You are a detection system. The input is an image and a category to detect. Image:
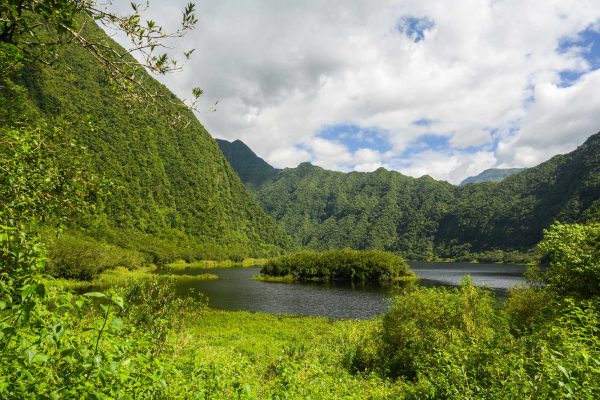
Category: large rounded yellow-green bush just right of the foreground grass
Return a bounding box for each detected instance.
[353,280,506,379]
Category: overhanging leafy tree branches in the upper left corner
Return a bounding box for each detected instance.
[0,0,202,108]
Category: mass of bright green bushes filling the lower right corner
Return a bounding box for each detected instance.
[346,284,600,399]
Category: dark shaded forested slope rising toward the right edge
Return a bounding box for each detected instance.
[438,133,600,251]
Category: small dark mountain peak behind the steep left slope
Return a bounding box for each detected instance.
[216,139,278,188]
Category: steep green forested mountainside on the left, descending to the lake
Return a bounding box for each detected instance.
[0,24,292,259]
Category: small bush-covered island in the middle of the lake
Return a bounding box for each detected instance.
[257,249,415,285]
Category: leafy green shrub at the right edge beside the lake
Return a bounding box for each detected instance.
[538,223,600,297]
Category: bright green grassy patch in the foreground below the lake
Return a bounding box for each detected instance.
[164,309,399,399]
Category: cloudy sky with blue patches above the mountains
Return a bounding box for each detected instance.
[104,0,600,183]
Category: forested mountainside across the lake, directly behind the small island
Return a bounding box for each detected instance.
[256,163,456,258]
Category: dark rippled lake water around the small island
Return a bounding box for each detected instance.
[163,263,525,319]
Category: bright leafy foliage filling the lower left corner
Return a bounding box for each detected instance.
[0,227,203,399]
